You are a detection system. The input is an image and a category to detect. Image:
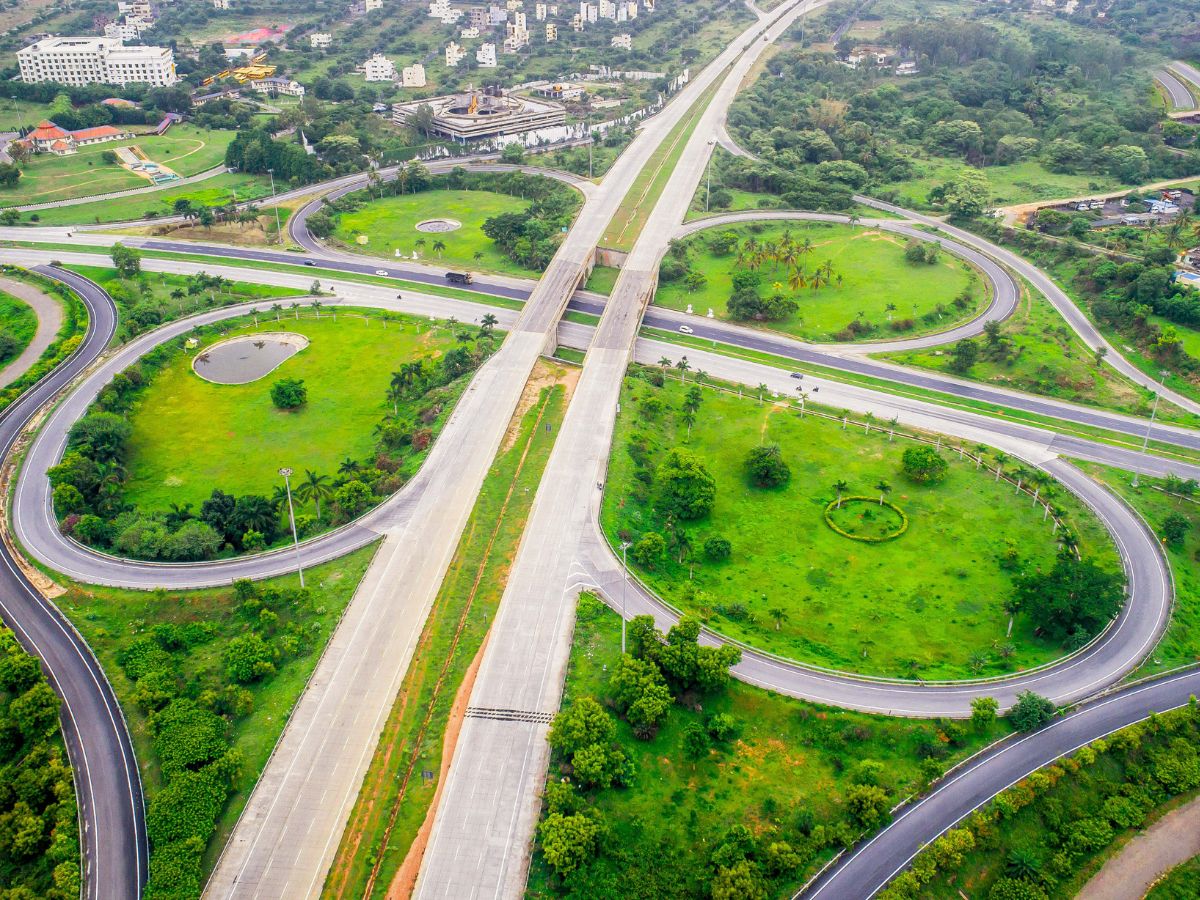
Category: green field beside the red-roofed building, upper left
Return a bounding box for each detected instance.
[0,125,234,206]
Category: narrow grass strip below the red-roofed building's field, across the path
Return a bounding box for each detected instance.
[22,172,271,226]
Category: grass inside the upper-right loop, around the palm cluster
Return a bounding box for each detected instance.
[654,222,988,341]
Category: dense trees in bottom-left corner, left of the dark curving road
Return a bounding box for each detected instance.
[0,628,82,900]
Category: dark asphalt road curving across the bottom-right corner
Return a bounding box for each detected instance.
[797,671,1200,900]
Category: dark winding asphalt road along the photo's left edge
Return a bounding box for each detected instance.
[0,266,148,900]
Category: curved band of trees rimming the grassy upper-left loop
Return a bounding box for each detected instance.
[308,163,580,270]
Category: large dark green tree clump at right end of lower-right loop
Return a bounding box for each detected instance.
[1014,556,1124,641]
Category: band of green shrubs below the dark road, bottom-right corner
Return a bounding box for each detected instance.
[880,697,1200,900]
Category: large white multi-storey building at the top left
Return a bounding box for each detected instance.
[17,37,179,86]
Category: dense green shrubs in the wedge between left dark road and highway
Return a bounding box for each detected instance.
[116,581,324,900]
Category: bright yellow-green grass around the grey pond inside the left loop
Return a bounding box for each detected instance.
[125,310,455,511]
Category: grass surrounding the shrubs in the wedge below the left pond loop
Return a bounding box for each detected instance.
[55,545,374,883]
